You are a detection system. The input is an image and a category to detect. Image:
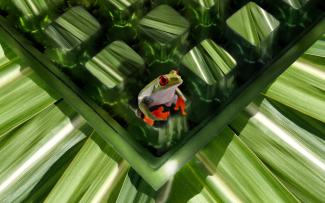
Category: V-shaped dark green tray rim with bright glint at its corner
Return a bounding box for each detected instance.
[0,16,325,189]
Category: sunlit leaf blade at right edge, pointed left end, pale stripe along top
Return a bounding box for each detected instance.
[265,60,325,122]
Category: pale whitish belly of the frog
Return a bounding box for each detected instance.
[149,87,177,107]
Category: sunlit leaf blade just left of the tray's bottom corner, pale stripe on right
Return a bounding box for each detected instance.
[45,135,129,202]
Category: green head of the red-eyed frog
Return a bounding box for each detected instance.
[155,70,183,91]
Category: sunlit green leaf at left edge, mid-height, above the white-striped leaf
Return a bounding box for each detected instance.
[0,50,55,137]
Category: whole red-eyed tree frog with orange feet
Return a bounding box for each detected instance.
[138,70,186,126]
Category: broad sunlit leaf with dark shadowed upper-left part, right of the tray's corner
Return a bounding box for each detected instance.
[166,128,297,202]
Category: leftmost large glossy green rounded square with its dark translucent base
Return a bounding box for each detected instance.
[44,7,100,67]
